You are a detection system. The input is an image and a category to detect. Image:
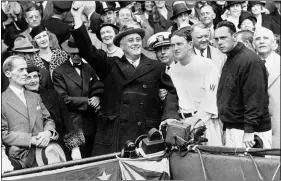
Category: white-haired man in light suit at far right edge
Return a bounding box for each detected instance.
[254,27,280,148]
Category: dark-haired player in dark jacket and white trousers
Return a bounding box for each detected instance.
[215,21,272,148]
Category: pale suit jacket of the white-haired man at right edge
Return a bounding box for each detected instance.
[266,52,280,148]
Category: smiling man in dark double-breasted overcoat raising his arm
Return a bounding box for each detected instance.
[71,1,179,156]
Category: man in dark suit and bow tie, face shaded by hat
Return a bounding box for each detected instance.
[53,37,103,160]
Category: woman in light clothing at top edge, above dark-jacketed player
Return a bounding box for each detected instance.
[221,1,244,30]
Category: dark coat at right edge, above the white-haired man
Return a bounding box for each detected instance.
[262,10,281,35]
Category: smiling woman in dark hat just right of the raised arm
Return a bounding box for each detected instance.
[97,23,124,58]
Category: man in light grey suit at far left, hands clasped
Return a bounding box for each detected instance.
[1,55,61,169]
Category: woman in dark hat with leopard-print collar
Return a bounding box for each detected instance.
[30,25,67,79]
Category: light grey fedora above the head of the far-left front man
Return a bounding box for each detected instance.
[12,37,39,53]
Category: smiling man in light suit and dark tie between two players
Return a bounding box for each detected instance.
[191,23,226,72]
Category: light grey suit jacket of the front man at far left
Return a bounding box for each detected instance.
[1,88,56,159]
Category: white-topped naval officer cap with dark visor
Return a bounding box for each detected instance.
[147,32,171,50]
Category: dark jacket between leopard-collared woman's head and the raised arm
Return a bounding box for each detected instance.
[43,17,70,45]
